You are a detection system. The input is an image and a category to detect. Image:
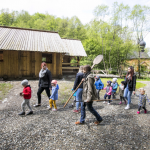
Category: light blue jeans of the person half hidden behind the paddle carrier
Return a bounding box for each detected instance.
[76,88,83,110]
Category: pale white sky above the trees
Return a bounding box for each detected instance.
[0,0,150,47]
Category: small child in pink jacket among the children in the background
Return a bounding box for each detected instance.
[103,81,112,105]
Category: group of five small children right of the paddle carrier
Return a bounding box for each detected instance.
[95,76,150,114]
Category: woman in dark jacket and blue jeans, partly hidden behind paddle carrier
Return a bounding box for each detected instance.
[73,66,84,113]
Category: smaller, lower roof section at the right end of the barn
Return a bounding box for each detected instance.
[62,39,87,56]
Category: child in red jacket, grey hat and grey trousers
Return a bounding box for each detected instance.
[18,79,33,115]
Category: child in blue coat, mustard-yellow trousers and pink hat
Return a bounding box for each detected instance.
[48,80,59,111]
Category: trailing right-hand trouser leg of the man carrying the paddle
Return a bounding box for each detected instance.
[86,102,103,121]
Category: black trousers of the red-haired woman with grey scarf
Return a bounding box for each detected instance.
[37,87,51,104]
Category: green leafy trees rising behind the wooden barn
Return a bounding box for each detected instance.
[0,2,150,73]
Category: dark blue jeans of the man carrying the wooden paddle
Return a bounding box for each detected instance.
[80,102,103,123]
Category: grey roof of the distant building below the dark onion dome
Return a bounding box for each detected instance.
[128,51,150,59]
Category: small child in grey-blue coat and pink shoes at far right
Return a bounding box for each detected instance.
[136,88,150,114]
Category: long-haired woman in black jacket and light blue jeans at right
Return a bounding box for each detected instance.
[124,66,136,109]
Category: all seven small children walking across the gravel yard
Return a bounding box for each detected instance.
[19,76,149,115]
